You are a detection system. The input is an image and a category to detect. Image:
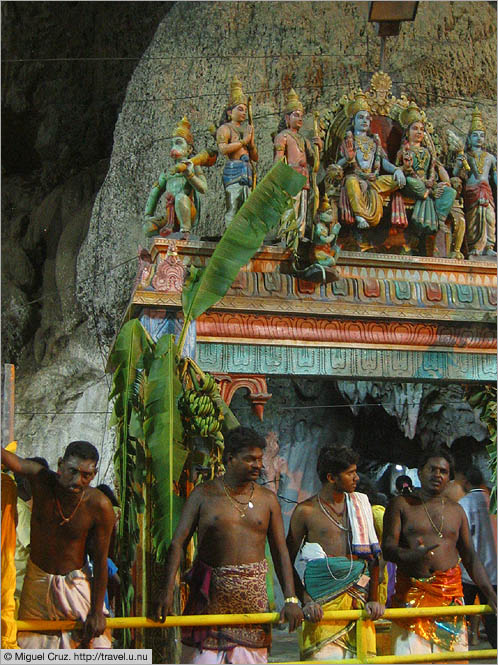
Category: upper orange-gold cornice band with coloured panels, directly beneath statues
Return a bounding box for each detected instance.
[132,238,496,324]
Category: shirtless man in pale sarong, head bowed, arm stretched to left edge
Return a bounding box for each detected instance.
[2,441,114,649]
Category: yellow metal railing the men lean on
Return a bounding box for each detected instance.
[17,605,497,665]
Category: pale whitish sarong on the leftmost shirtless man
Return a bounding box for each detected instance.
[18,559,111,649]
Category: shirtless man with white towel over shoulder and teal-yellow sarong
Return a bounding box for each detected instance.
[287,446,384,662]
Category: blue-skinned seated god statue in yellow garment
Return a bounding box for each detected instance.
[337,91,405,229]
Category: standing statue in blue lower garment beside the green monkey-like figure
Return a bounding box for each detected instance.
[216,78,258,228]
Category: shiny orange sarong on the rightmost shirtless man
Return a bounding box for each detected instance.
[392,566,467,651]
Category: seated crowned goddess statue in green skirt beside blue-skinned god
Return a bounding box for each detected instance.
[396,102,456,235]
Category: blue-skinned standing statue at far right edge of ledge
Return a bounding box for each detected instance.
[453,107,496,256]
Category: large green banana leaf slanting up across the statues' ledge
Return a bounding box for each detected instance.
[179,161,306,330]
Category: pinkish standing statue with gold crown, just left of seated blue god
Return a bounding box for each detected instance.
[273,88,323,237]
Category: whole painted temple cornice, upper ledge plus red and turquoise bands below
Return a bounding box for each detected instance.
[127,238,496,384]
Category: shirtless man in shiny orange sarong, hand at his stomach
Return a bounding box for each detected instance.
[382,447,496,655]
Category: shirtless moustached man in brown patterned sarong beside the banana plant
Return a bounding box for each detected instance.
[153,427,303,663]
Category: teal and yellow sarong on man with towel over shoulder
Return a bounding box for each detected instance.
[299,557,375,660]
